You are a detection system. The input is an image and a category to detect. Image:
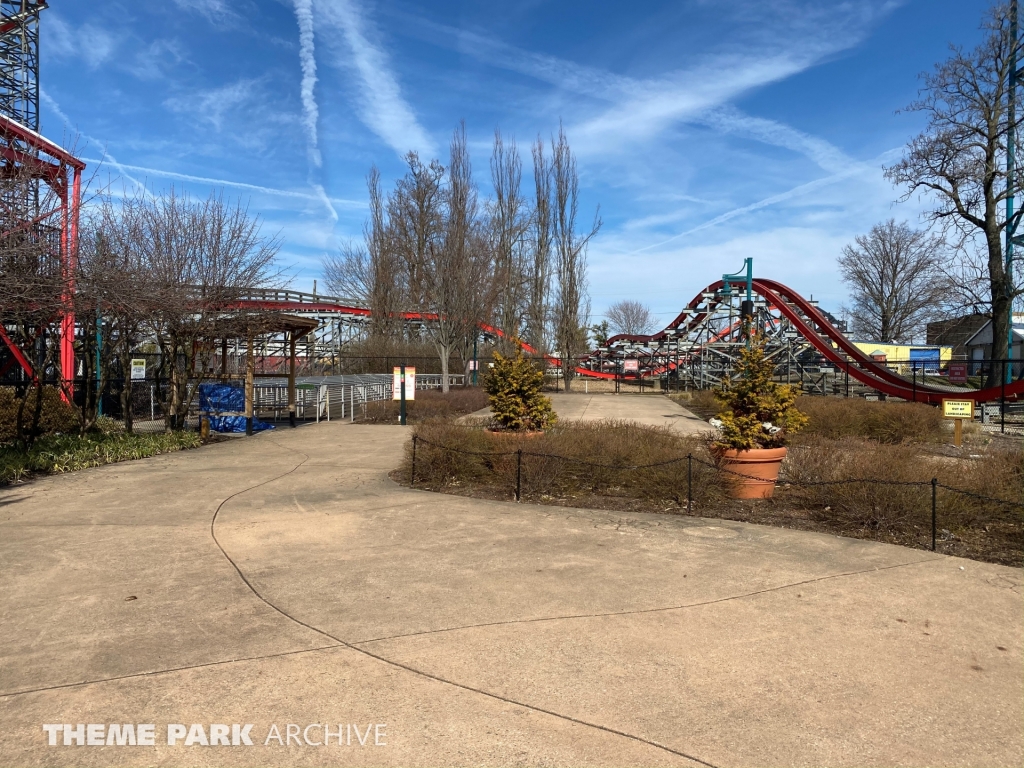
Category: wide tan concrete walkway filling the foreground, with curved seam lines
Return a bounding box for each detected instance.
[0,423,1024,766]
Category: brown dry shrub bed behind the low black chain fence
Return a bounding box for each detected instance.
[392,421,1024,565]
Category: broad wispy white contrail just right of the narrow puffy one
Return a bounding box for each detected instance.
[316,0,436,157]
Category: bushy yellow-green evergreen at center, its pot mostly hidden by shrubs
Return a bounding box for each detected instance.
[484,339,556,432]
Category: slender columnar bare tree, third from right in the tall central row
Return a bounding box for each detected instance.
[489,130,530,352]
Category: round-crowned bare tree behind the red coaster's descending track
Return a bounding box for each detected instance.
[839,219,948,343]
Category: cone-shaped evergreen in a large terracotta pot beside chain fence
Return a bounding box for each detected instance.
[712,334,807,499]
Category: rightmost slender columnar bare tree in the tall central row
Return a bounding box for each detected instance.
[551,126,601,391]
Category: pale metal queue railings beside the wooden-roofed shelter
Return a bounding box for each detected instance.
[255,374,466,422]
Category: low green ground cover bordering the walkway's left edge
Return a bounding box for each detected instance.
[0,432,200,484]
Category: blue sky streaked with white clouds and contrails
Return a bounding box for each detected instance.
[41,0,987,322]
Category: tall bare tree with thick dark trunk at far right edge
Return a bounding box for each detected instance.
[886,4,1022,370]
